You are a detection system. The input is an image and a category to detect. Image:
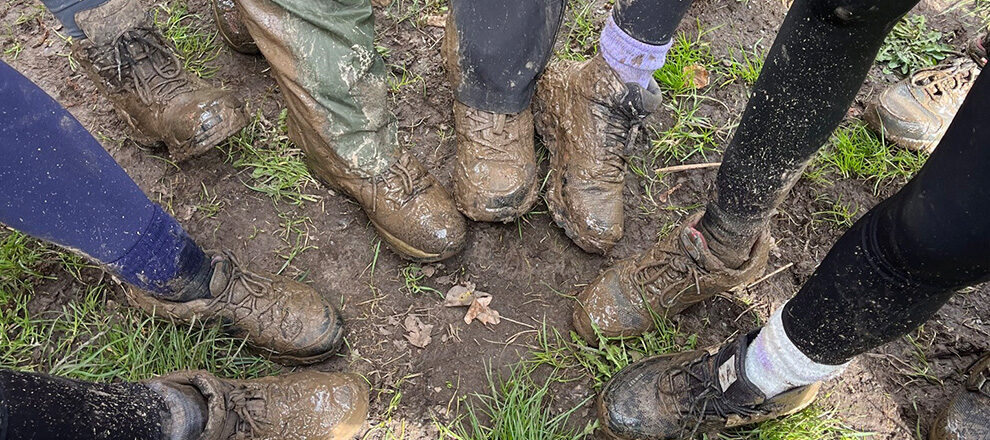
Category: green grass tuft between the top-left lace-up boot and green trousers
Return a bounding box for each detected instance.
[153,0,223,78]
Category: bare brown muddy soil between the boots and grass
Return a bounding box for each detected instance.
[0,0,990,439]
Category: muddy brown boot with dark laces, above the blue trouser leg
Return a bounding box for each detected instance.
[72,0,248,162]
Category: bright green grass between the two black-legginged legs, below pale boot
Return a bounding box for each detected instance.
[805,122,928,191]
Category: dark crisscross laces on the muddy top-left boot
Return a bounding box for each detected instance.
[88,28,192,105]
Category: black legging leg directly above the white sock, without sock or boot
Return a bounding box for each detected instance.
[782,71,990,365]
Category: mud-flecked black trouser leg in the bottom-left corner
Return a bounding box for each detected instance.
[0,369,168,440]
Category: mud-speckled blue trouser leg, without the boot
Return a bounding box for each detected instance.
[0,62,210,300]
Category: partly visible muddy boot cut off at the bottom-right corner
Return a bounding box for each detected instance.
[928,353,990,440]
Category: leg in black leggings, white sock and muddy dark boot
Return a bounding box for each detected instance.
[601,49,990,438]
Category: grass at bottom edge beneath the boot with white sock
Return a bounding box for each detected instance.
[717,405,873,440]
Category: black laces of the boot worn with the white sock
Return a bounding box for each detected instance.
[659,353,768,438]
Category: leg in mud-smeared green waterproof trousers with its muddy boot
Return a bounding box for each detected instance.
[237,0,466,261]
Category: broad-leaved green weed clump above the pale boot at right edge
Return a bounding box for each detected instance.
[877,14,952,75]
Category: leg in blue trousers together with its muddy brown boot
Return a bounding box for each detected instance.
[0,63,343,364]
